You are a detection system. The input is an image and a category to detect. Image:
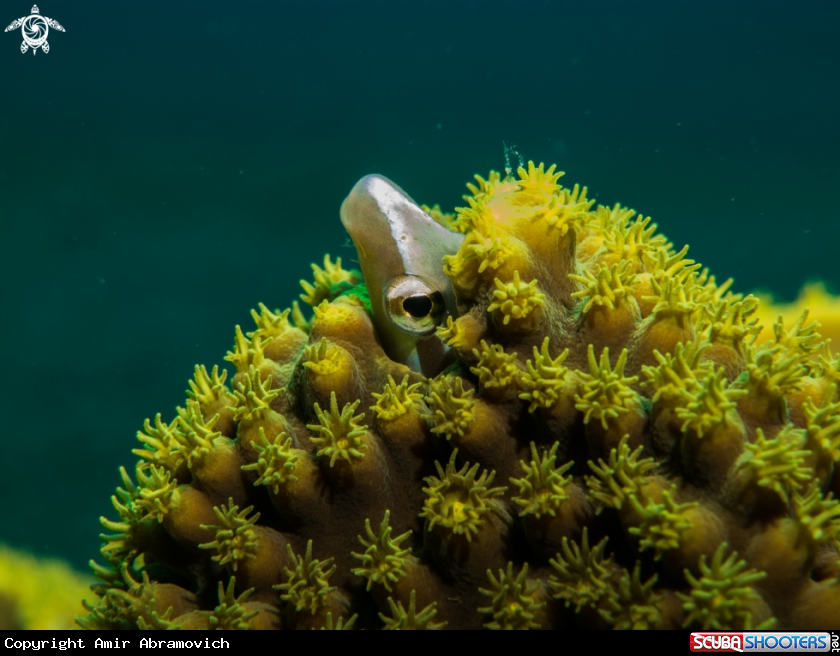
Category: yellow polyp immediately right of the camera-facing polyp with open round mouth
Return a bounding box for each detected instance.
[510,442,574,517]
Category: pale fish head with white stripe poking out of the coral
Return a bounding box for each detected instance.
[340,174,464,377]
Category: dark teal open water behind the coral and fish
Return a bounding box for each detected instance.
[0,0,840,567]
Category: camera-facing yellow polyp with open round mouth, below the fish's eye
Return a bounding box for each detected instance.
[420,449,507,541]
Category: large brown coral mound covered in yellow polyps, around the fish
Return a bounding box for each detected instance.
[79,163,840,630]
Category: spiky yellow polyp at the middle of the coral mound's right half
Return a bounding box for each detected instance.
[575,344,639,430]
